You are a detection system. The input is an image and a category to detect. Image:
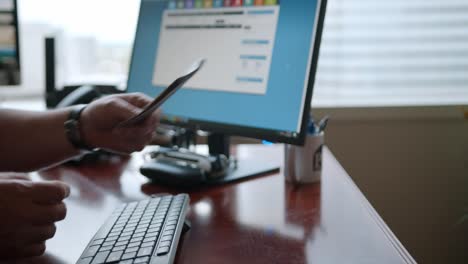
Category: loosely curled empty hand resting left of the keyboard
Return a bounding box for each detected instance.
[0,174,70,260]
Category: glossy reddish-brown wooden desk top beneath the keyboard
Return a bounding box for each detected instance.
[23,146,414,264]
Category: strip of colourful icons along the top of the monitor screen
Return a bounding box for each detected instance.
[169,0,280,9]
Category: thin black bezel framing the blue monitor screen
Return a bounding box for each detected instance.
[127,0,327,145]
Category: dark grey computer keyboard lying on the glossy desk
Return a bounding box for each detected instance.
[76,194,189,264]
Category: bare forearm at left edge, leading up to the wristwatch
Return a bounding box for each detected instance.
[0,109,79,172]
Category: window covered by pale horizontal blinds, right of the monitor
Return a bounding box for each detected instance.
[313,0,468,107]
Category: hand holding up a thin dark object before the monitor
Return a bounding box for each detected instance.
[80,93,160,153]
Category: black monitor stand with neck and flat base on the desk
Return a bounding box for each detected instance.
[202,133,280,185]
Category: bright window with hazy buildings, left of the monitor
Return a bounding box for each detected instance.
[0,0,140,97]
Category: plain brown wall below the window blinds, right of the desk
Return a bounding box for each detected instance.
[313,107,468,263]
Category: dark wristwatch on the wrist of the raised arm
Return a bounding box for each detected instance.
[64,105,95,152]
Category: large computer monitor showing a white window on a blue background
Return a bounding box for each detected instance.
[128,0,325,144]
